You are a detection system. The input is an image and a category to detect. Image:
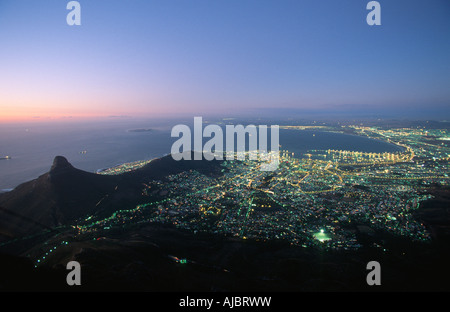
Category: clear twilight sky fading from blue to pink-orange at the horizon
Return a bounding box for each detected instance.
[0,0,450,122]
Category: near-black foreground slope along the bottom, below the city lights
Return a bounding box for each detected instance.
[0,225,450,292]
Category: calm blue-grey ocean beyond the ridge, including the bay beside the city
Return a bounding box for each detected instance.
[0,117,401,190]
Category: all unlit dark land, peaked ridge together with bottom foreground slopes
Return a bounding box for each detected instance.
[0,157,450,292]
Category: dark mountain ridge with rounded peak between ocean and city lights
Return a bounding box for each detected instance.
[0,155,220,242]
